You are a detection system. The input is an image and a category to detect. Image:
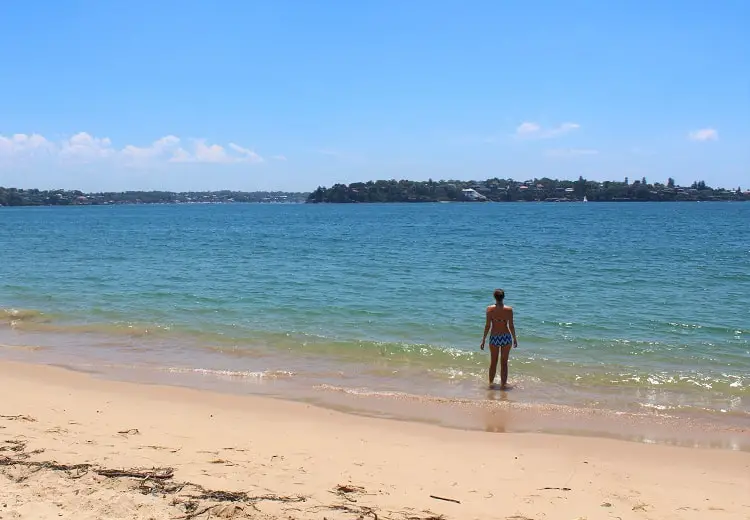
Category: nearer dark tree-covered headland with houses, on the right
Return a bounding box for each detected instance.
[307,177,750,203]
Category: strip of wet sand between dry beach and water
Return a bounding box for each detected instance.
[0,330,750,452]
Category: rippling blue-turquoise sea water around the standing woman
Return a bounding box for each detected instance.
[0,203,750,425]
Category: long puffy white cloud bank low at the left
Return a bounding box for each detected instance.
[0,132,270,166]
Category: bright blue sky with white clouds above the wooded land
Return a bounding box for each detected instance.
[0,0,750,190]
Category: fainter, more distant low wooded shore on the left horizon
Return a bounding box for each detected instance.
[0,187,308,206]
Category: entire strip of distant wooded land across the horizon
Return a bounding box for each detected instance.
[0,177,750,206]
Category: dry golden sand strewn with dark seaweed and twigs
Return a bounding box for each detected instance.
[0,362,750,520]
